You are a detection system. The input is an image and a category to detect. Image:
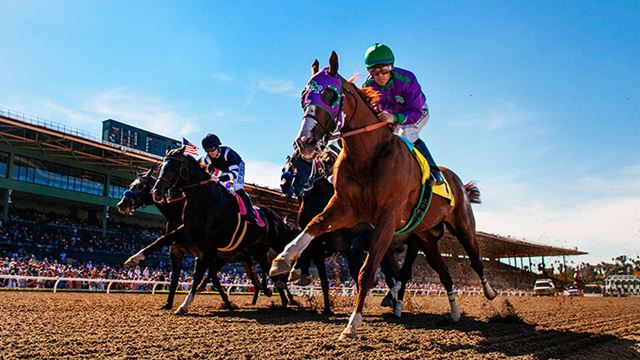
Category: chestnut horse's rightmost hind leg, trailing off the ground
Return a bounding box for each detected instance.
[447,215,497,300]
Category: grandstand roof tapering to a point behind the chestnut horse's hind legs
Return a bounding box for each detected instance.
[440,231,587,259]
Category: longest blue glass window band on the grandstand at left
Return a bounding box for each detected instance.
[13,155,105,196]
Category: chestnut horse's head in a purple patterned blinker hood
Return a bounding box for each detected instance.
[295,52,343,161]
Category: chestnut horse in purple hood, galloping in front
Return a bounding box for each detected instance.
[270,52,496,339]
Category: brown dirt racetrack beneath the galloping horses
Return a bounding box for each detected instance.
[0,292,640,360]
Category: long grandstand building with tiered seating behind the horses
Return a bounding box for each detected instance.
[0,108,585,288]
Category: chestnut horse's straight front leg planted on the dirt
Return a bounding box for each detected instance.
[340,213,395,340]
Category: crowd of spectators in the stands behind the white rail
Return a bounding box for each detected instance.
[0,212,535,293]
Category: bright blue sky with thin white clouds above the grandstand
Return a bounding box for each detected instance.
[0,0,640,262]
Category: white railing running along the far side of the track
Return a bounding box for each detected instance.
[0,275,533,296]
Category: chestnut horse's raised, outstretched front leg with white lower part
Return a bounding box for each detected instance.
[269,196,356,277]
